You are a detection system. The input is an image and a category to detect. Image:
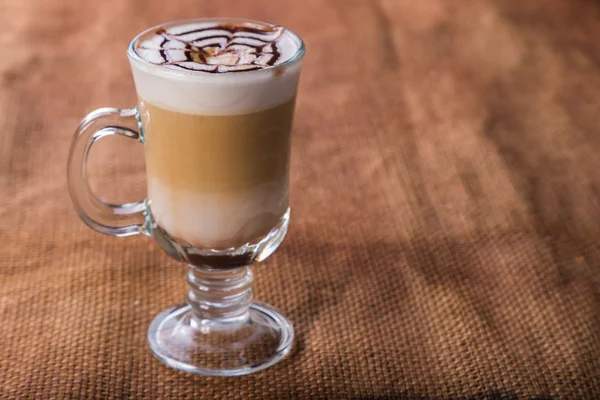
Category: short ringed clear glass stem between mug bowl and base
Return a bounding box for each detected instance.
[187,265,253,329]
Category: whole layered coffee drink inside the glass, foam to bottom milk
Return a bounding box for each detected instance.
[131,21,300,249]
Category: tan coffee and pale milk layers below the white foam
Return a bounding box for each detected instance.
[139,98,294,248]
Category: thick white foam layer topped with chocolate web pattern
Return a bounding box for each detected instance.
[128,19,304,115]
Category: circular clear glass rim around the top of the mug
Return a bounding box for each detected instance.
[127,17,306,79]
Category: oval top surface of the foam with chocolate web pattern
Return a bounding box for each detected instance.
[136,23,284,73]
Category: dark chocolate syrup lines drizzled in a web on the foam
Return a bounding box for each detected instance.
[139,24,284,73]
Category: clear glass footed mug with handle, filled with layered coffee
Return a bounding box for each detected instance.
[68,19,305,376]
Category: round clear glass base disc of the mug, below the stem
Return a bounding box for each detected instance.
[148,303,294,376]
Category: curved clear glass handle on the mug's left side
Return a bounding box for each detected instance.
[67,107,146,236]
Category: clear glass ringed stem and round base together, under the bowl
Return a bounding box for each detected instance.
[148,267,294,376]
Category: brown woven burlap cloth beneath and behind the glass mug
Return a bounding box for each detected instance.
[0,0,600,399]
